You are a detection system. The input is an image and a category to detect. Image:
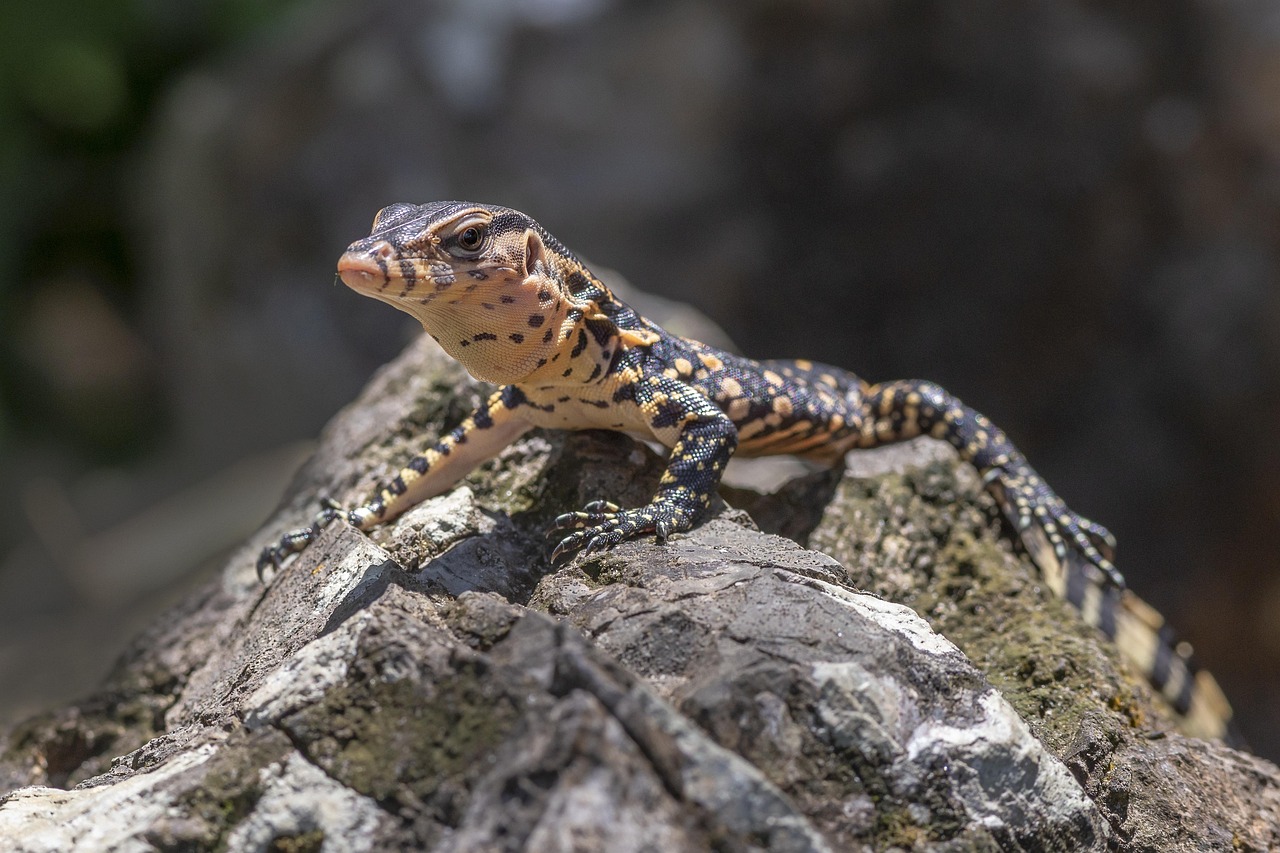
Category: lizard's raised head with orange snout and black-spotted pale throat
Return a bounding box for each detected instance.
[338,201,584,384]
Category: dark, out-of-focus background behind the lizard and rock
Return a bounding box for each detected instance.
[0,0,1280,758]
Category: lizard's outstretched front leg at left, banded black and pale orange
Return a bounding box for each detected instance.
[257,386,532,579]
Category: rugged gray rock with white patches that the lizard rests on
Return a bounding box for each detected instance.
[0,338,1280,850]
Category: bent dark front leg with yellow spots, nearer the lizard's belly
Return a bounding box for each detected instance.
[550,380,737,562]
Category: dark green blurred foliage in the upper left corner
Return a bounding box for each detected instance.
[0,0,307,461]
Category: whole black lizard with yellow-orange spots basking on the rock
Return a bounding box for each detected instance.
[259,201,1228,737]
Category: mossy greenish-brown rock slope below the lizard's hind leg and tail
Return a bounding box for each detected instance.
[809,450,1171,754]
